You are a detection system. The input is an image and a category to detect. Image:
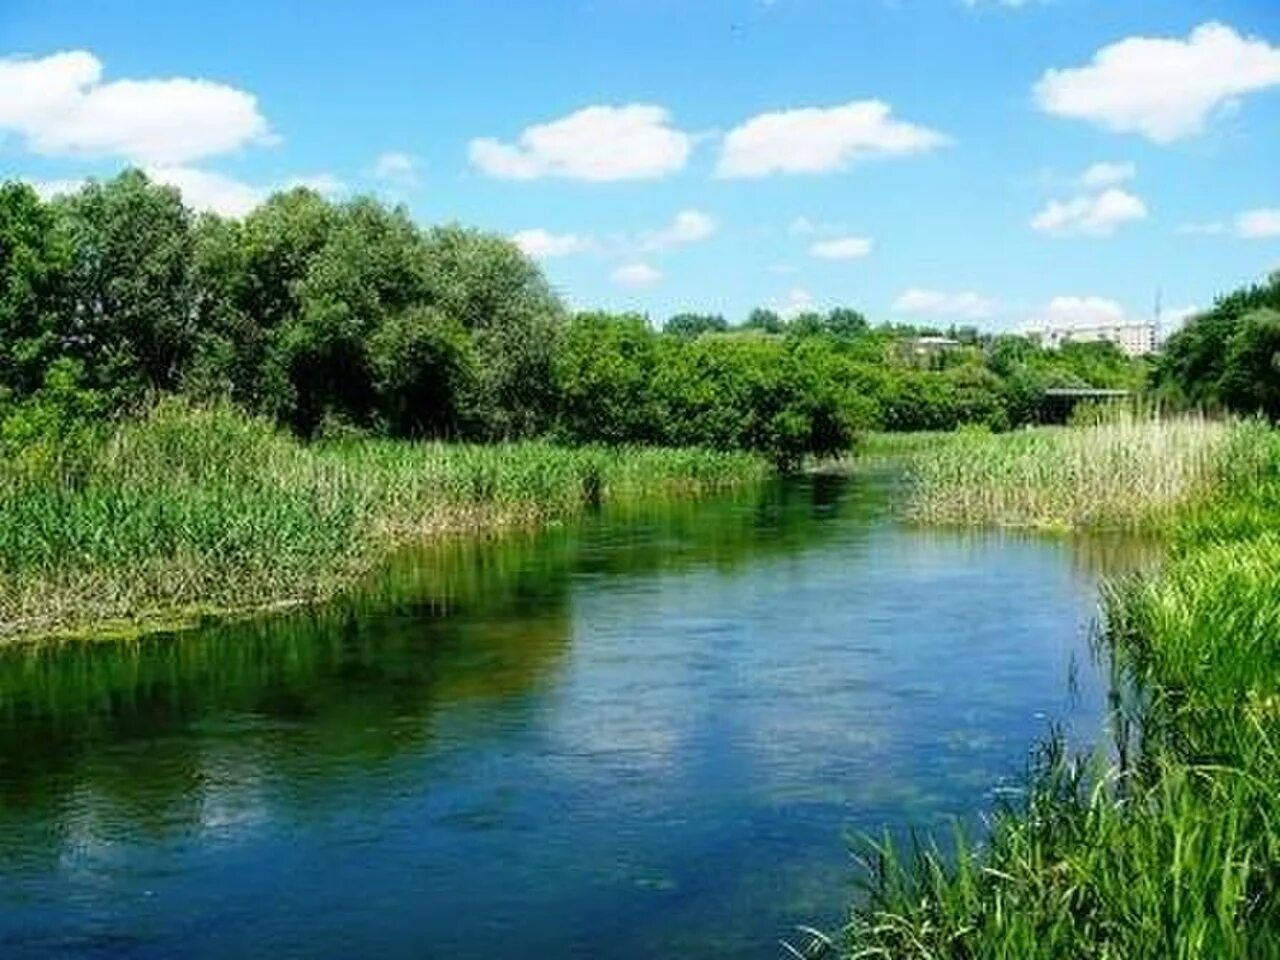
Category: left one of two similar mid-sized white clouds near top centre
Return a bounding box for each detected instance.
[468,104,692,182]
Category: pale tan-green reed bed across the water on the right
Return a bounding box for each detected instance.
[908,417,1262,530]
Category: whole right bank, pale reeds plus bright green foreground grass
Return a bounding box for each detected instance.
[838,421,1280,960]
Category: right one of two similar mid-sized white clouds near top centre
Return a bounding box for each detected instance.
[716,100,947,178]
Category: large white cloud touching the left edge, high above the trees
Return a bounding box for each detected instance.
[0,50,271,166]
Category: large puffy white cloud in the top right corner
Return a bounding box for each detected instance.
[1034,23,1280,143]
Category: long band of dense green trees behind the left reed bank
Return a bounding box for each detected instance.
[0,170,1152,465]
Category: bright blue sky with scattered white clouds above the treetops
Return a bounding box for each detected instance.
[0,0,1280,329]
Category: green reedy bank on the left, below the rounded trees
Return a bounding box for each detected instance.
[0,402,765,639]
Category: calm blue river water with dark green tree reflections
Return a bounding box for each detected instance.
[0,477,1114,960]
